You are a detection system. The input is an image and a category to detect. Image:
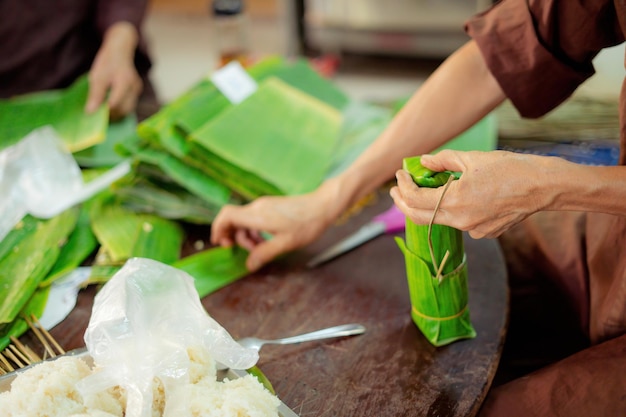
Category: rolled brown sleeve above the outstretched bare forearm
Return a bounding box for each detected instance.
[465,0,624,117]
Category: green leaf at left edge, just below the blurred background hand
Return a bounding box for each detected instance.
[0,76,109,152]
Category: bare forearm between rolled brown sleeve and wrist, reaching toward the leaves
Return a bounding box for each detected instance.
[321,42,505,211]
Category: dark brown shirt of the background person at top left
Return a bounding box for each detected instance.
[0,0,150,98]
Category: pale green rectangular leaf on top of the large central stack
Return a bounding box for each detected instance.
[191,77,341,195]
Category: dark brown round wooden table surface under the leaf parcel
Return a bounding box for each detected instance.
[51,194,508,417]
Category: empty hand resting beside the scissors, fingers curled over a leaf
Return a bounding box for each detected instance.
[211,190,339,272]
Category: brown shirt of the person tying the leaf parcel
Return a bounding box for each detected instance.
[466,0,626,343]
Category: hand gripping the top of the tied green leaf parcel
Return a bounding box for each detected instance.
[390,150,559,238]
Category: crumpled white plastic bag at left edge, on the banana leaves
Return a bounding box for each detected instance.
[0,126,130,240]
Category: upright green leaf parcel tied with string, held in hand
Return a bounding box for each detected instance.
[396,157,476,346]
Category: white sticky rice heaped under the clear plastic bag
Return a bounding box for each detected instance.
[0,348,298,417]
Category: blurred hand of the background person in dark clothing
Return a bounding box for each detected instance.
[85,22,143,120]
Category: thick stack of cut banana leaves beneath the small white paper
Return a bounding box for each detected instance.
[118,57,349,211]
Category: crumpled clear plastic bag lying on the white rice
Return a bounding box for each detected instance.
[78,258,258,417]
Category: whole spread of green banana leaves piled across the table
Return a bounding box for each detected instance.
[0,57,392,349]
